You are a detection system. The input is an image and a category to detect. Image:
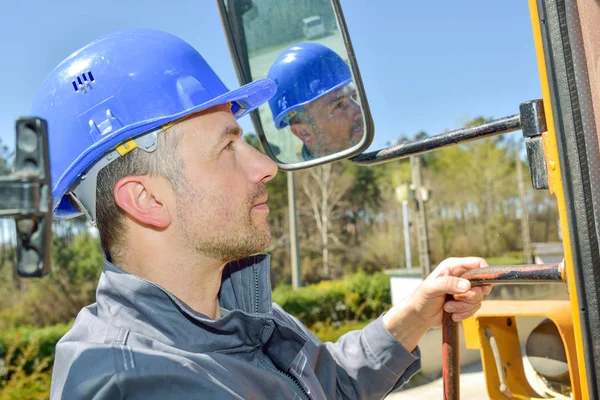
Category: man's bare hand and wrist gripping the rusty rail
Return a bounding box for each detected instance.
[383,257,492,351]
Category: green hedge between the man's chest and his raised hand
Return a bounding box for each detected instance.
[273,272,391,327]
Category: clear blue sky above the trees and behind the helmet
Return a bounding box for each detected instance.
[0,0,541,153]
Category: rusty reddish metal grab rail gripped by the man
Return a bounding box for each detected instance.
[442,260,565,400]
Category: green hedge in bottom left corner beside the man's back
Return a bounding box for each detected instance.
[0,324,71,400]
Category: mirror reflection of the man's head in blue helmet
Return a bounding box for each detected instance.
[267,43,364,160]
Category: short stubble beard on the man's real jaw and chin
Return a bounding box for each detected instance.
[177,184,271,262]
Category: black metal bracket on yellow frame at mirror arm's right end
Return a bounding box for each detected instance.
[519,100,548,189]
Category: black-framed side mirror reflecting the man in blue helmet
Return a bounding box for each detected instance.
[217,0,374,171]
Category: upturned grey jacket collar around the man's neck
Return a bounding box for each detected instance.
[96,255,273,352]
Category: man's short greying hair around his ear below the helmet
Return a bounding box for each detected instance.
[96,125,185,261]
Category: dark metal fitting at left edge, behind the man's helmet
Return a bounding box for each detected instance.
[0,118,52,277]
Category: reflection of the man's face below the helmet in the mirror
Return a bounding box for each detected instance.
[290,84,364,157]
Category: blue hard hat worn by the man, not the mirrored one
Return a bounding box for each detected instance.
[31,29,276,222]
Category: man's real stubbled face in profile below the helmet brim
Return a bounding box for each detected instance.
[175,106,277,262]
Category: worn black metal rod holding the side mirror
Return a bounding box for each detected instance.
[351,110,521,165]
